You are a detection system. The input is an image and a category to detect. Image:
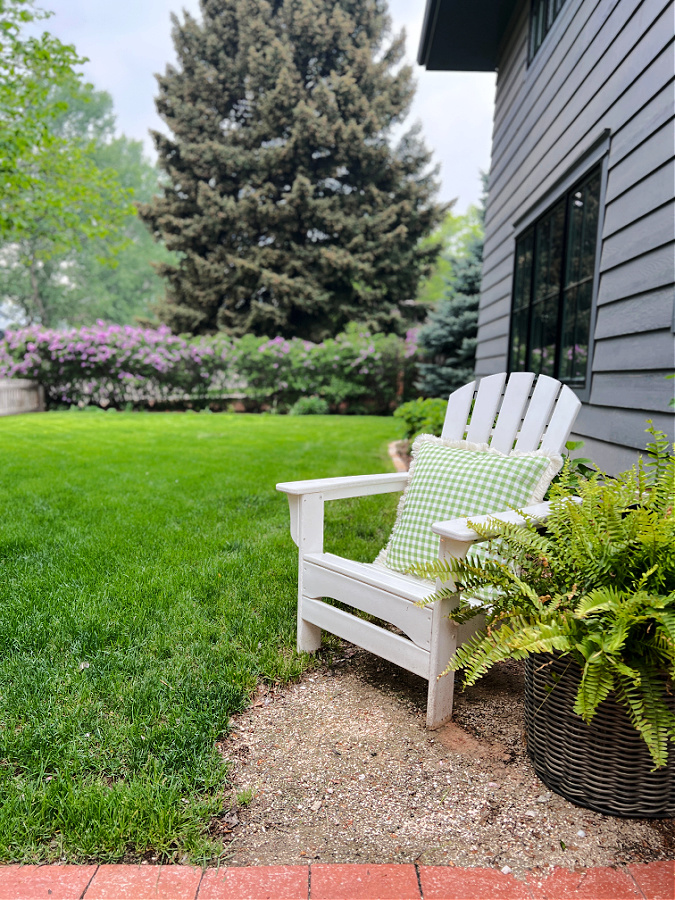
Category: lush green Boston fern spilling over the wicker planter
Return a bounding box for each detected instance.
[416,432,675,767]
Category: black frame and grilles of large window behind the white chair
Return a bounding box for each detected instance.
[508,164,607,399]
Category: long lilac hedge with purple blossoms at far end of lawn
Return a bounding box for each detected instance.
[0,322,416,413]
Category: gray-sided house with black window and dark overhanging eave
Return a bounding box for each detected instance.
[418,0,675,471]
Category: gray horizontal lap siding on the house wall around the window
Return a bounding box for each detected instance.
[476,0,675,469]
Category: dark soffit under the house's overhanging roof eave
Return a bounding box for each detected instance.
[417,0,518,72]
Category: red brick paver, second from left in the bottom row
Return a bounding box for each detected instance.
[86,866,202,900]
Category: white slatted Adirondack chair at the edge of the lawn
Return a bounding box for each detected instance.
[277,372,581,728]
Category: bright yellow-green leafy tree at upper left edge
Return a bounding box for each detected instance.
[0,0,133,298]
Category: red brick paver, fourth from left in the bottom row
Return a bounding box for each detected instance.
[310,865,420,900]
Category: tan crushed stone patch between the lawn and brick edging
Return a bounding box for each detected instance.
[217,645,675,875]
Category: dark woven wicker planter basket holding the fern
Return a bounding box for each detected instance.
[525,654,675,818]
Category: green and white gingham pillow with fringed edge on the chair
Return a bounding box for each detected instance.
[375,434,562,572]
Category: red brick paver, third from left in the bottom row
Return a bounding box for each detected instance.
[198,866,309,900]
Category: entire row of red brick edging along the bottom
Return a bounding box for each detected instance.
[0,860,675,900]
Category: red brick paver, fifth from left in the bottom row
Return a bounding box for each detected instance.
[420,866,531,900]
